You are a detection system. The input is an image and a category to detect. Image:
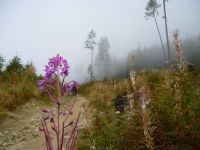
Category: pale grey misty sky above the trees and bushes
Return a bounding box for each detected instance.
[0,0,200,81]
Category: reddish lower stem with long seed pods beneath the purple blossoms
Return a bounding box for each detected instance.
[41,98,80,150]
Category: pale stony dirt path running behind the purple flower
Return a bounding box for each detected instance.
[0,97,88,150]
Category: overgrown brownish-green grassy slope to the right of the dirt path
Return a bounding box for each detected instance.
[78,70,200,150]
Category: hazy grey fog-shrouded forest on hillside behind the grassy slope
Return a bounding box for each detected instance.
[95,37,200,80]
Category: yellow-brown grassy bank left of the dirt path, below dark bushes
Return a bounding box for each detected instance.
[0,74,44,120]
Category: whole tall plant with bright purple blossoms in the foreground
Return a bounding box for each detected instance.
[38,54,80,150]
